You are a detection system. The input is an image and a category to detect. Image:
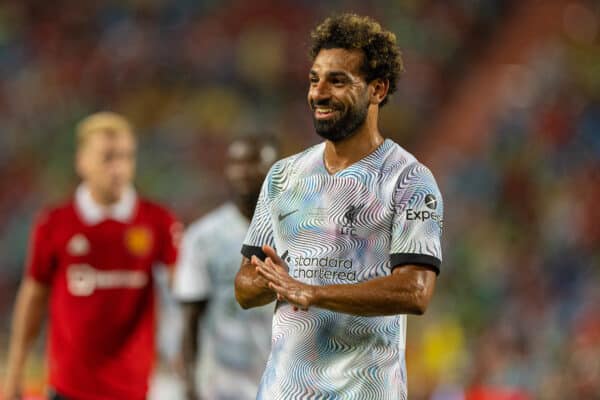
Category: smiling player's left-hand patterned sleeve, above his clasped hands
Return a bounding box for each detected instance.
[242,164,277,260]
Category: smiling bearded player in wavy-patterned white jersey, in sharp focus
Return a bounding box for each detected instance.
[236,14,443,400]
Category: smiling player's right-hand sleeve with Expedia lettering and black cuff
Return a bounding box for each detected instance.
[390,163,444,274]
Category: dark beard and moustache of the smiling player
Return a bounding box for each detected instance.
[311,96,369,142]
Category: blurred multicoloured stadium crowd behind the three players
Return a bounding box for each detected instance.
[0,0,600,400]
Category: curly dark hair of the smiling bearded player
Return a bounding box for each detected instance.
[309,13,404,107]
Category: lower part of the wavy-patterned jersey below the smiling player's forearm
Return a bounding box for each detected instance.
[259,305,401,399]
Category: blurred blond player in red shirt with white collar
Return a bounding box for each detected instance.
[4,112,180,400]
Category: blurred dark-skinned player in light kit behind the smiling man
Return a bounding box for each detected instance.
[174,135,277,400]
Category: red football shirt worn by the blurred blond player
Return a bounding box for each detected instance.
[27,188,179,400]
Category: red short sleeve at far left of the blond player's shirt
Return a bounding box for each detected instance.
[25,212,58,284]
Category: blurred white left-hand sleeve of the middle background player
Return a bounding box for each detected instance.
[173,225,211,301]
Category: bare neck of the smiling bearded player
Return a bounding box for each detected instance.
[323,116,383,174]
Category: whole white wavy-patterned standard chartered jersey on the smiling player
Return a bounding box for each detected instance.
[245,140,442,400]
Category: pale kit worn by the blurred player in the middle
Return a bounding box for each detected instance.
[174,203,273,400]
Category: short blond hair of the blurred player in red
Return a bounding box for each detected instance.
[75,111,135,148]
